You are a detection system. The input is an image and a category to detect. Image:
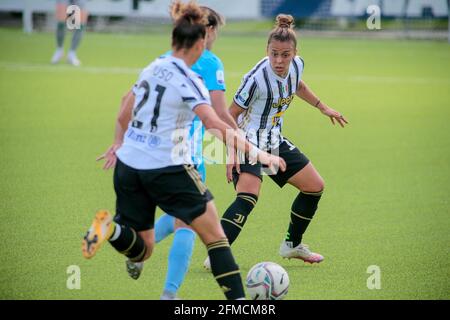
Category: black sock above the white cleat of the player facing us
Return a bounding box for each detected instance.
[286,191,323,248]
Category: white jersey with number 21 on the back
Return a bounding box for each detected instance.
[116,56,211,170]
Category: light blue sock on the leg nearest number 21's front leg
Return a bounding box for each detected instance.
[164,228,195,295]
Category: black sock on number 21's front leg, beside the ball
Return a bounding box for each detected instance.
[207,239,245,300]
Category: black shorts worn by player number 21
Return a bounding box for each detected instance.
[114,159,213,231]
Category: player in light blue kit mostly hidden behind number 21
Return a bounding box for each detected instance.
[149,6,237,300]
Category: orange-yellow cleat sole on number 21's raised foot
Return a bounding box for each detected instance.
[81,210,114,259]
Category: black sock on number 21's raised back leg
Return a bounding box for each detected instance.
[109,224,146,262]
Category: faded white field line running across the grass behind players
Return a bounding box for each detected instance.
[0,61,450,85]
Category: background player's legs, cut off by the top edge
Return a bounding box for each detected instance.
[51,0,88,67]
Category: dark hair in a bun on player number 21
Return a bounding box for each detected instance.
[170,0,208,50]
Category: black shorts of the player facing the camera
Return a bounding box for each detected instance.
[233,138,309,188]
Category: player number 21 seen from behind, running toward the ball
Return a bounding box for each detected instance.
[82,0,286,299]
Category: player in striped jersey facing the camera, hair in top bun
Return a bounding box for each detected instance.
[205,14,347,269]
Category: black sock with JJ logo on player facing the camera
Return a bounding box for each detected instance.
[220,193,258,245]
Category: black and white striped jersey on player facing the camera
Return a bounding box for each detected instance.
[234,56,304,150]
